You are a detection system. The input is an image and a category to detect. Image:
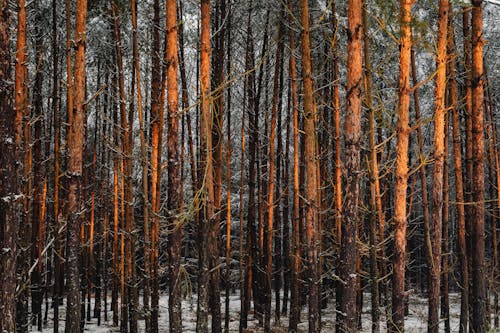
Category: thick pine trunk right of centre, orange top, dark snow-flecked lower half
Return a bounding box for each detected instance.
[340,0,363,332]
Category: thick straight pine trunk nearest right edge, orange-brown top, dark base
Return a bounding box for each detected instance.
[471,0,489,332]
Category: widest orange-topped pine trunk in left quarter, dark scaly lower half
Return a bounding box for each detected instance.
[66,0,87,333]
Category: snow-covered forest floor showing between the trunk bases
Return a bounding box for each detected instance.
[32,293,484,333]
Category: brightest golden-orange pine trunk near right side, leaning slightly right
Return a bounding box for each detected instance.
[427,0,449,333]
